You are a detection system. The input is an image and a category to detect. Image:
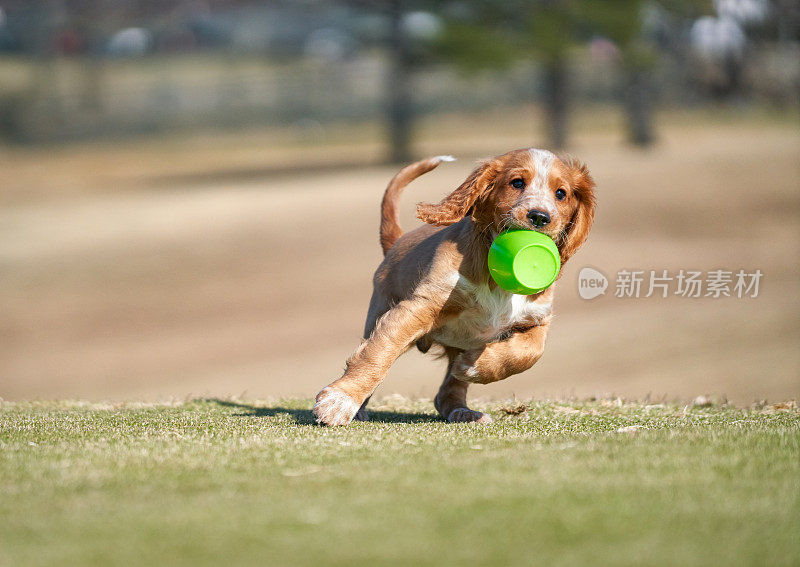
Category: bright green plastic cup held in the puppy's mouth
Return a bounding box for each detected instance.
[488,230,561,295]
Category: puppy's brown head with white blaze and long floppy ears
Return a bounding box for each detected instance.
[417,149,595,262]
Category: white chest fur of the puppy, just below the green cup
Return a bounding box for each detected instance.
[431,276,551,349]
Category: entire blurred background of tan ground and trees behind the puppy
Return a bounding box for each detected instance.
[0,0,800,404]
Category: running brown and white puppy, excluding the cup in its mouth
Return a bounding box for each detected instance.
[314,149,595,425]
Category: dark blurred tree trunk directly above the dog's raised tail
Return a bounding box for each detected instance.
[386,0,413,163]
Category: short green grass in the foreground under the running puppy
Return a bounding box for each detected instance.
[0,399,800,566]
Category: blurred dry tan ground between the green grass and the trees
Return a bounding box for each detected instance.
[0,108,800,403]
